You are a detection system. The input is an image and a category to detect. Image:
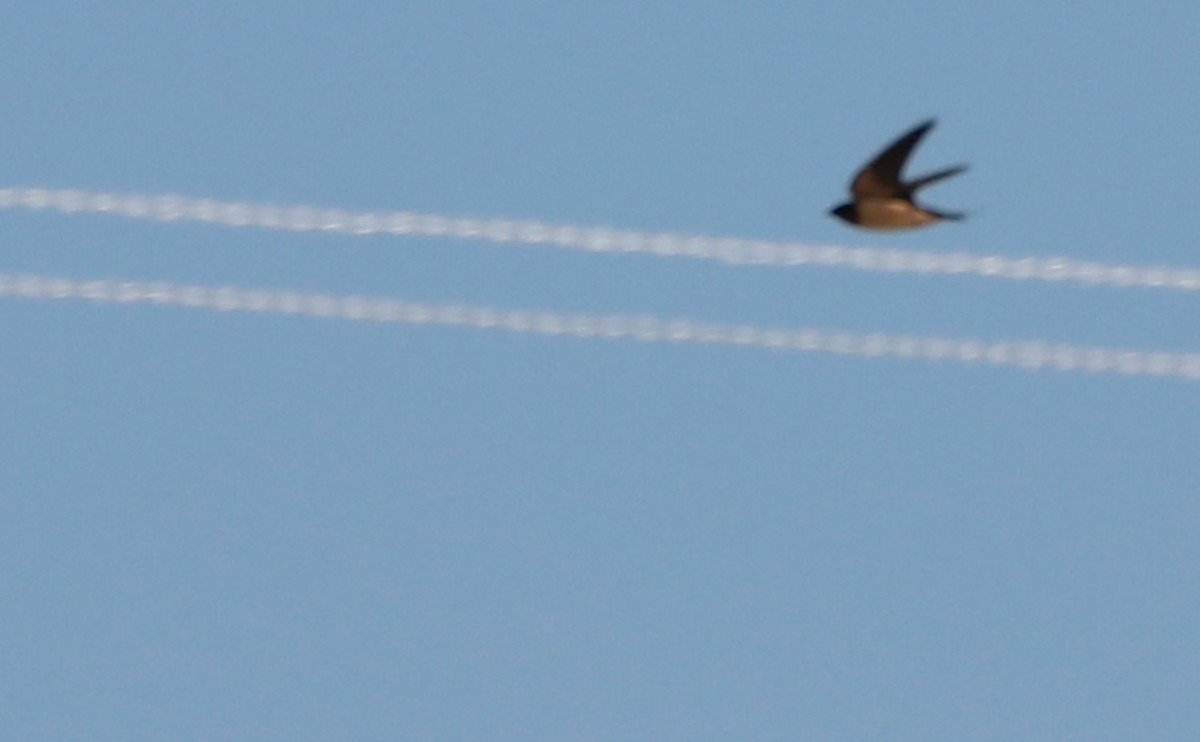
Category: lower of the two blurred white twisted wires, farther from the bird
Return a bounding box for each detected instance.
[0,274,1200,381]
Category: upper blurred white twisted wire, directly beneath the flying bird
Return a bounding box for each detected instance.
[0,183,1200,291]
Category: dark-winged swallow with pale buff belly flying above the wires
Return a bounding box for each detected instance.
[829,119,967,232]
